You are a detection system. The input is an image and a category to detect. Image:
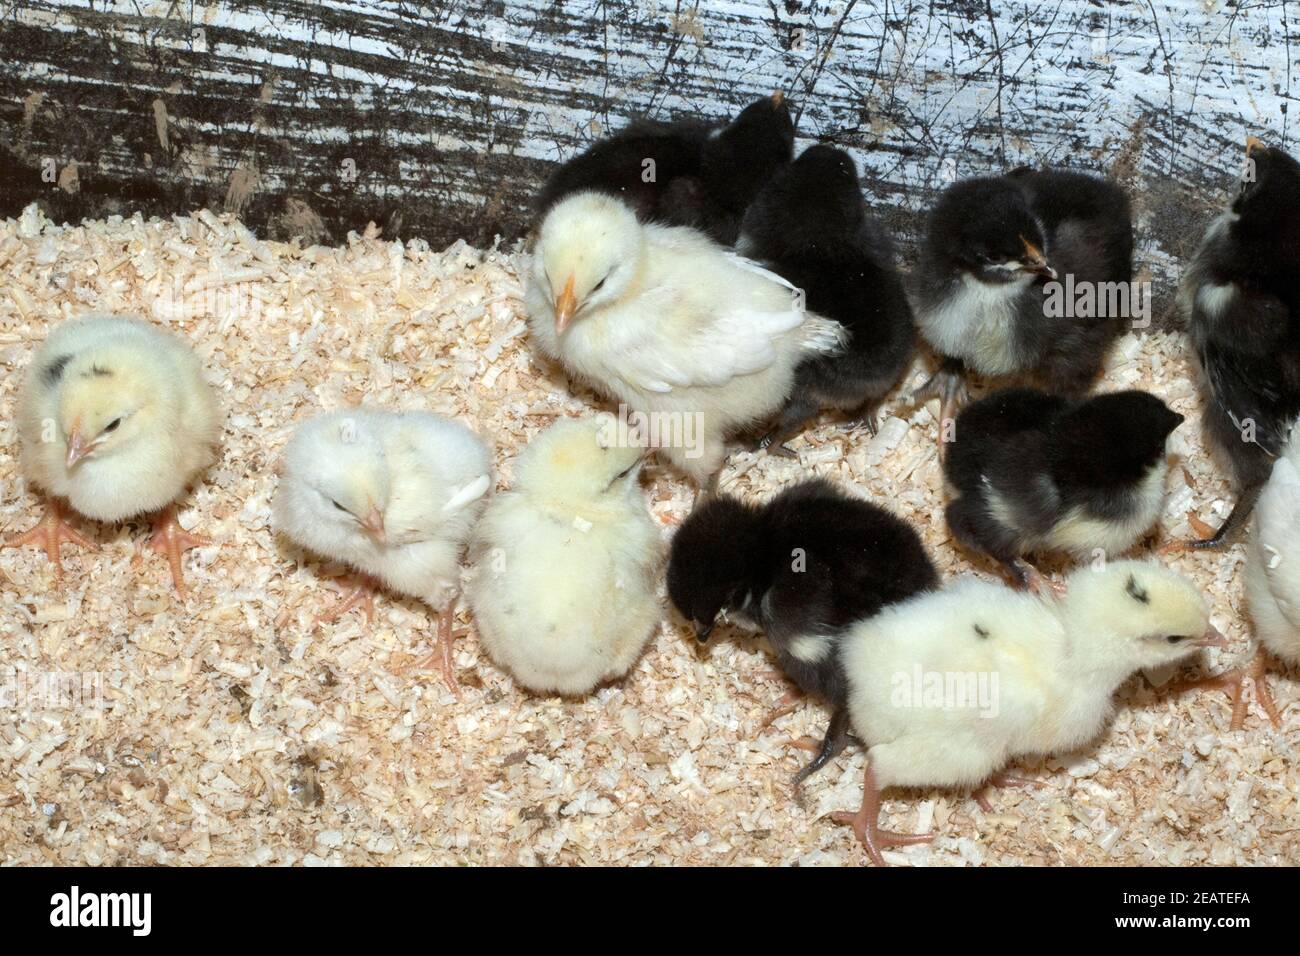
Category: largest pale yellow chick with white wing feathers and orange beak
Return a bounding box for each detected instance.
[524,193,845,486]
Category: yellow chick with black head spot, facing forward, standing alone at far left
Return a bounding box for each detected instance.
[7,315,221,594]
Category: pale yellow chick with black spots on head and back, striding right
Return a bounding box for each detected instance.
[833,561,1226,866]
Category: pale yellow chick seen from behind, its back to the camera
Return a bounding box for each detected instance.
[468,415,662,695]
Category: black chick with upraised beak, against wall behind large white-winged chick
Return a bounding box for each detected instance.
[537,94,794,246]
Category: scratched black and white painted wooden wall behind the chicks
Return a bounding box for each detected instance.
[0,0,1300,311]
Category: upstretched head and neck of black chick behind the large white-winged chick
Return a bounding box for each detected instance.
[664,92,794,246]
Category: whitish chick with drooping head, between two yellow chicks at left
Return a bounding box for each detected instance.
[272,408,493,692]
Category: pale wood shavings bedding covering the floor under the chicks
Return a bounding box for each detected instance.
[0,208,1300,865]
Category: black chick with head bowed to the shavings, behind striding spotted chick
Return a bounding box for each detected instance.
[668,480,939,783]
